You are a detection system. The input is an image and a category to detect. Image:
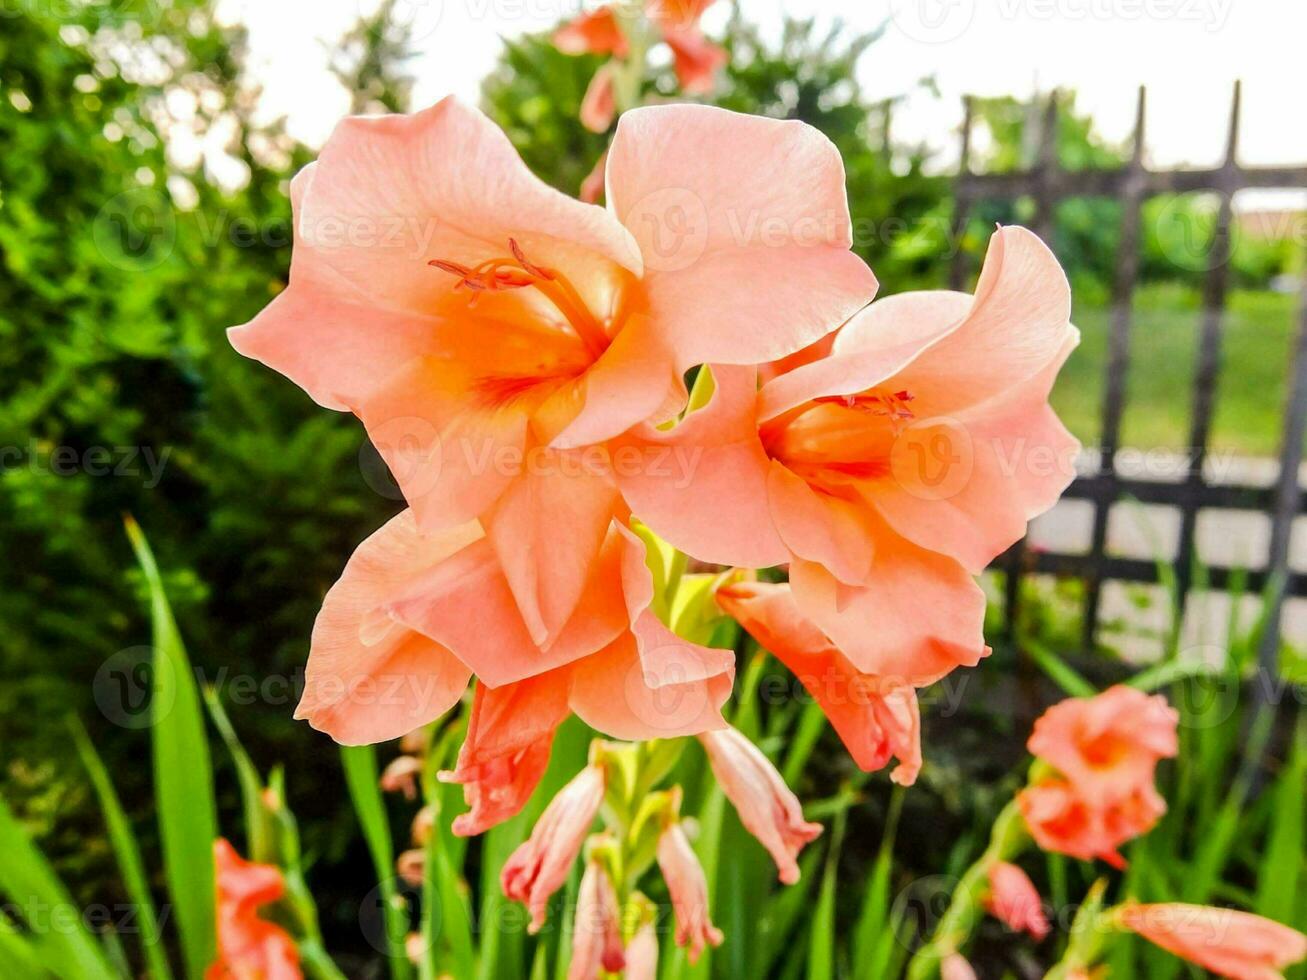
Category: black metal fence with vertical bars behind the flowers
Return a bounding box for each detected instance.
[949,84,1307,670]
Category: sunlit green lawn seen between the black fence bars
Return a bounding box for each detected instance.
[1052,284,1298,456]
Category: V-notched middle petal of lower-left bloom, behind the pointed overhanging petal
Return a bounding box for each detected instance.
[388,534,630,687]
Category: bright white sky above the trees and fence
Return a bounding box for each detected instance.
[220,0,1307,182]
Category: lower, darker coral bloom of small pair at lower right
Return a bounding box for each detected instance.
[1017,779,1166,868]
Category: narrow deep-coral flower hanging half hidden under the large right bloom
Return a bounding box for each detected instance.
[716,581,921,785]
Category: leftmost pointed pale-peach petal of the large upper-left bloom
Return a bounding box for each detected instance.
[227,163,435,412]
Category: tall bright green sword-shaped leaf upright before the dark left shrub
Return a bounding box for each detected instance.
[127,519,218,980]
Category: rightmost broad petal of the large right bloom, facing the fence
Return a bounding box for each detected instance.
[867,331,1080,572]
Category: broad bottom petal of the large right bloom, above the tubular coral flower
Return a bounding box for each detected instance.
[789,533,989,687]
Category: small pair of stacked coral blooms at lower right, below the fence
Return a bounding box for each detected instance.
[1017,686,1179,868]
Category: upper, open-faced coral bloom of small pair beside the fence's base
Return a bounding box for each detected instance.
[1027,685,1180,802]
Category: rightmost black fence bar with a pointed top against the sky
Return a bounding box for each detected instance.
[1175,82,1242,621]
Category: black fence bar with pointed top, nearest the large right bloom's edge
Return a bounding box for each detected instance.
[1081,85,1148,649]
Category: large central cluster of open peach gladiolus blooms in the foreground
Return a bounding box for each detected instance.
[231,99,1078,852]
